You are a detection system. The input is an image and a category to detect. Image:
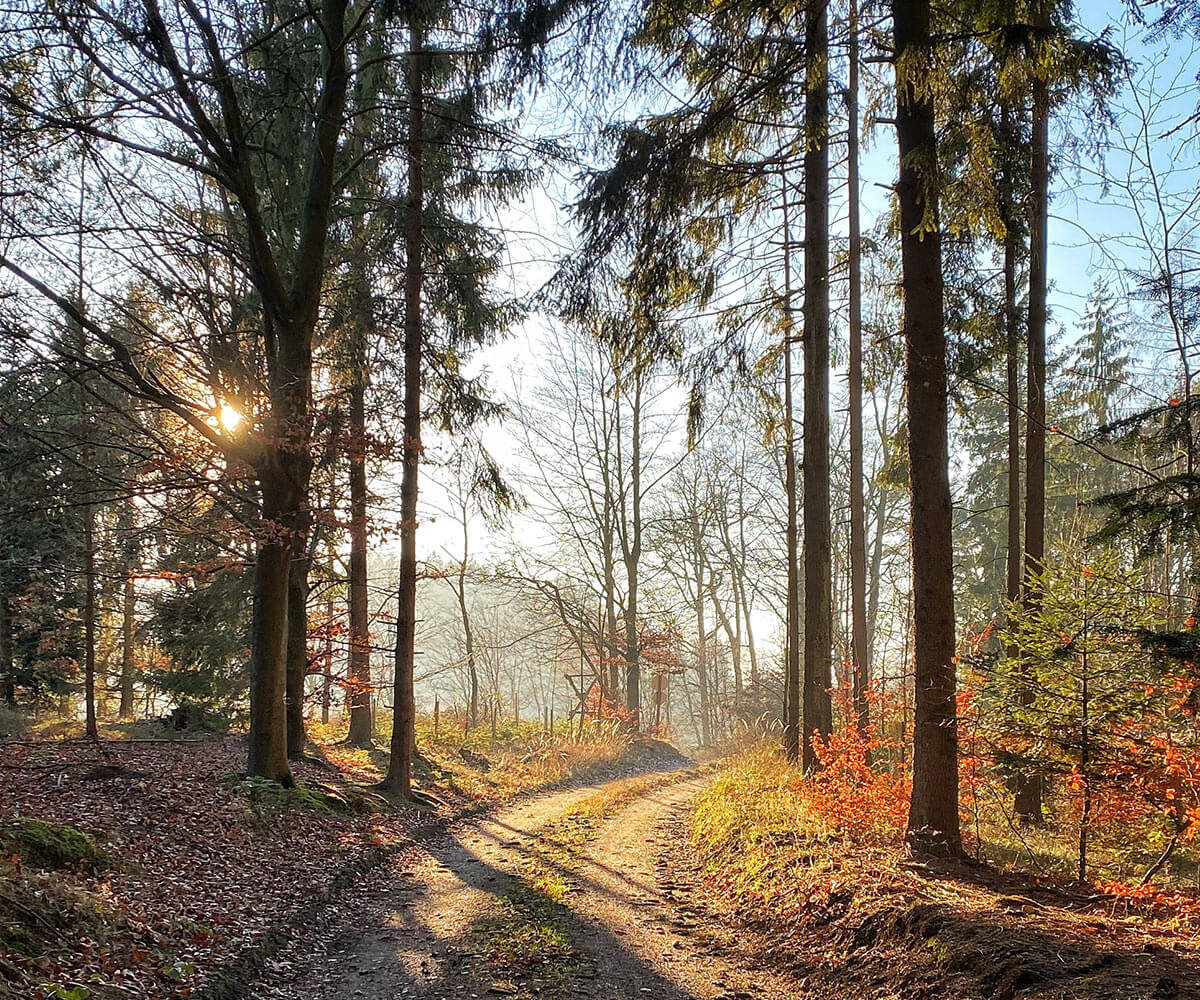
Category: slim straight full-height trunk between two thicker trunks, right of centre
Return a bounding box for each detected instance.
[846,0,871,732]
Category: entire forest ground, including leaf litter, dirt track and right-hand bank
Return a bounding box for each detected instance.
[0,738,1200,1000]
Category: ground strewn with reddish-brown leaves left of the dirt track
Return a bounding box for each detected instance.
[0,733,680,1000]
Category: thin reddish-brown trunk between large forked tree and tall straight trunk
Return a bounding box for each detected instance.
[346,338,374,747]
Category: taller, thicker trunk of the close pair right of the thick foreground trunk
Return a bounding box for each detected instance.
[1013,13,1050,824]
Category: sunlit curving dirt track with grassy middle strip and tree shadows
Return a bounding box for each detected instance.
[248,770,797,1000]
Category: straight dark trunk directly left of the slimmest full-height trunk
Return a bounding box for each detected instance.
[802,0,833,771]
